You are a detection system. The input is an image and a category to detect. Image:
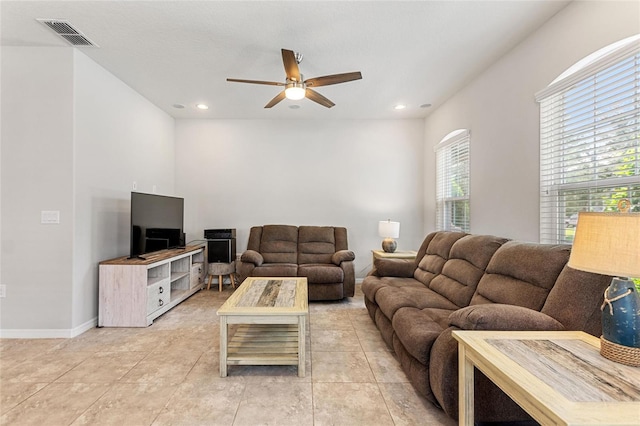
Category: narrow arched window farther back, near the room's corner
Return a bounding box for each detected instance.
[435,129,470,232]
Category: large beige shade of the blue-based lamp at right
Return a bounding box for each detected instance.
[568,212,640,278]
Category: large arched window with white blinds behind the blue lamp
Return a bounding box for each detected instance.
[536,35,640,243]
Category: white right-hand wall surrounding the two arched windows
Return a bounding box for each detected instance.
[425,1,640,241]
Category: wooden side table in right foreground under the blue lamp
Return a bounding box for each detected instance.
[453,330,640,426]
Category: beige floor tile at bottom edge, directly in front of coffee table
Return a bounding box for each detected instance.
[233,383,313,426]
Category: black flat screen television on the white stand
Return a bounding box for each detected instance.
[130,192,184,258]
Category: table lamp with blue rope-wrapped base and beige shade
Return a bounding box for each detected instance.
[568,207,640,367]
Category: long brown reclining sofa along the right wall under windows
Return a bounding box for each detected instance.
[362,231,611,422]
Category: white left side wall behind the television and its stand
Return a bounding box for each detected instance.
[72,50,175,329]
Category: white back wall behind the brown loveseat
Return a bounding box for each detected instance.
[176,120,424,276]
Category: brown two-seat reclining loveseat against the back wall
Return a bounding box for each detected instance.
[238,225,356,300]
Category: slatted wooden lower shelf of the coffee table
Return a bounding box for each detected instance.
[227,324,299,365]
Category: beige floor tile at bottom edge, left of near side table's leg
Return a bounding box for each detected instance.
[379,383,457,426]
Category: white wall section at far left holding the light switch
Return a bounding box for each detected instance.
[0,47,73,330]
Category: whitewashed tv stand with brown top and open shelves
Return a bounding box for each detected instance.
[98,246,206,327]
